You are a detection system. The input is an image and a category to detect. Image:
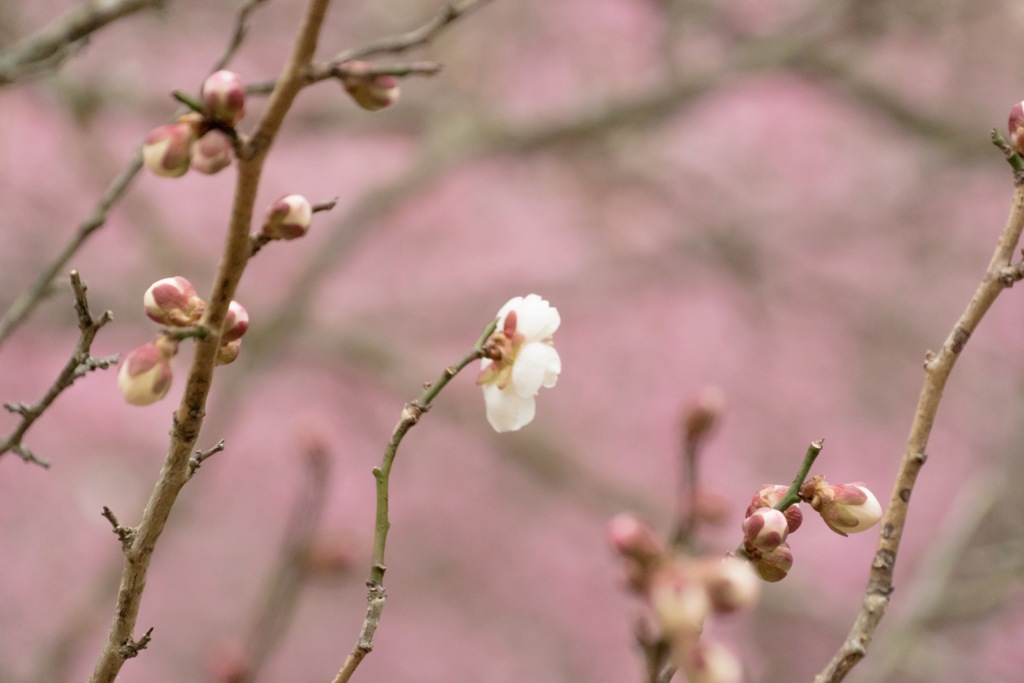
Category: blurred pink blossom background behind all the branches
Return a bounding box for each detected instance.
[0,0,1024,683]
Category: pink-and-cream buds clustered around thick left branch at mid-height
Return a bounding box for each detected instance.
[118,275,249,405]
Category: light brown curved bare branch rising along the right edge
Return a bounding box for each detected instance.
[814,184,1024,683]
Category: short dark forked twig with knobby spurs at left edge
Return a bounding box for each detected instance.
[0,270,118,467]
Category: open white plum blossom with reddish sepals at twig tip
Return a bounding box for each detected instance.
[476,294,562,432]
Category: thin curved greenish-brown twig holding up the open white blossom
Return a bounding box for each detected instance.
[332,321,498,683]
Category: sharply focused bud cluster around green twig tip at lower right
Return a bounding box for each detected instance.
[742,475,882,583]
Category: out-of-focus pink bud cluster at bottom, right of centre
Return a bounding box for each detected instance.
[608,514,761,683]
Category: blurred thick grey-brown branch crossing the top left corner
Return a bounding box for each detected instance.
[0,0,164,85]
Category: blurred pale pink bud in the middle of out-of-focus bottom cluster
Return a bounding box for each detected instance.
[647,562,711,636]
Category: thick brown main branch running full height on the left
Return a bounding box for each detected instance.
[90,0,329,683]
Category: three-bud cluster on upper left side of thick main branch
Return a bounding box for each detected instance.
[142,71,246,178]
